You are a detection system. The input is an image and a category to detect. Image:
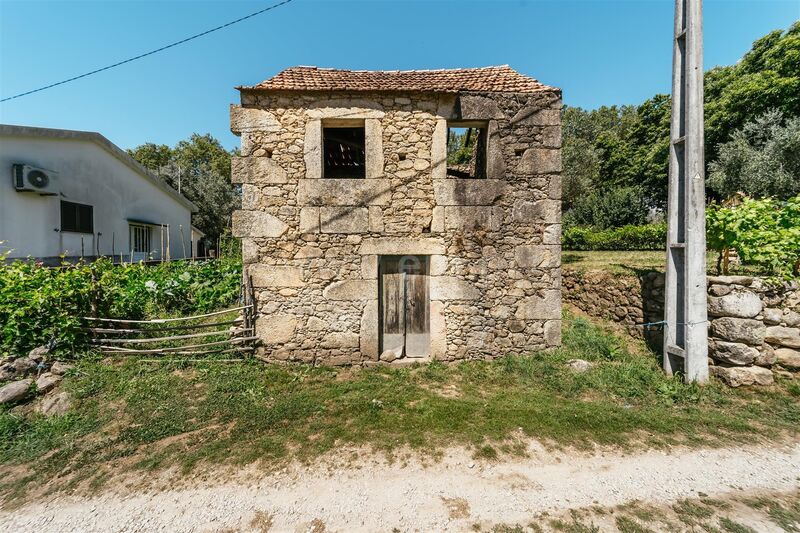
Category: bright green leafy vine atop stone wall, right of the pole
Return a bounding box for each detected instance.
[706,194,800,278]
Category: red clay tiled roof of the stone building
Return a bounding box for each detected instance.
[238,65,554,93]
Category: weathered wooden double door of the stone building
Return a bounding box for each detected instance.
[379,255,431,357]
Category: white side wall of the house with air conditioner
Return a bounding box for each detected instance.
[0,136,191,259]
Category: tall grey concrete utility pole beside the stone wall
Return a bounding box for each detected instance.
[664,0,708,383]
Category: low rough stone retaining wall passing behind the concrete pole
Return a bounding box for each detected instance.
[563,269,800,386]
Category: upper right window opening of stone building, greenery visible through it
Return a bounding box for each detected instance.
[447,121,488,179]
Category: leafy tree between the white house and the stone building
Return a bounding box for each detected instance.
[128,133,240,242]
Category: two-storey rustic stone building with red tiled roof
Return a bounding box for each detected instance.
[231,66,561,364]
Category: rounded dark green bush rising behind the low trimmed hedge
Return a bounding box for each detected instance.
[564,187,648,229]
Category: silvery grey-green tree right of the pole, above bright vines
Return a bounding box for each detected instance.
[708,110,800,199]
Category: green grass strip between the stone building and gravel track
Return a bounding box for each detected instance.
[0,316,800,498]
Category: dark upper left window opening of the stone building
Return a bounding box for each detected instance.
[322,120,366,179]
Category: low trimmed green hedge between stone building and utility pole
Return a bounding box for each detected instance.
[562,224,667,251]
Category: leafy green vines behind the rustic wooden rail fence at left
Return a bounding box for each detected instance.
[0,257,242,355]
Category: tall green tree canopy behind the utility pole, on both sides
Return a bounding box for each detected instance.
[562,22,800,224]
